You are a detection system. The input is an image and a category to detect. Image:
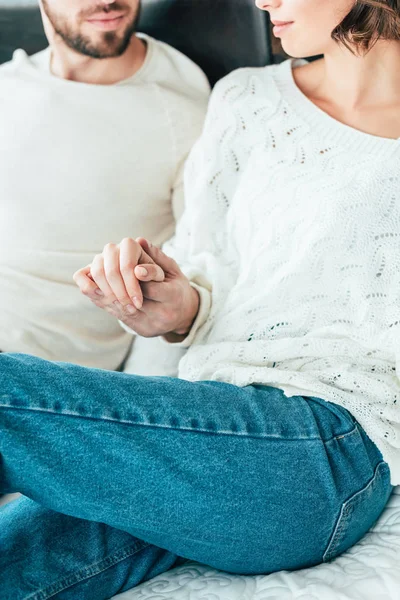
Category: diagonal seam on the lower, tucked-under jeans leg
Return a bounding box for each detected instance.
[24,541,151,600]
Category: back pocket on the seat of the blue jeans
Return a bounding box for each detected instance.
[323,461,393,562]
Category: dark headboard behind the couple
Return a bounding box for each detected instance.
[0,0,272,84]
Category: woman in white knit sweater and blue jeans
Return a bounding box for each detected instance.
[0,0,400,600]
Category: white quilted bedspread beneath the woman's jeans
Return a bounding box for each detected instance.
[114,487,400,600]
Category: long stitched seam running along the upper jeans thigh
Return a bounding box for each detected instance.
[0,402,324,442]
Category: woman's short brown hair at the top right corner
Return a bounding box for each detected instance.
[332,0,400,54]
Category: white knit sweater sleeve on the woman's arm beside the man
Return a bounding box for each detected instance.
[162,74,250,347]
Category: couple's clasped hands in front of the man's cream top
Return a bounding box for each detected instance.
[74,238,200,342]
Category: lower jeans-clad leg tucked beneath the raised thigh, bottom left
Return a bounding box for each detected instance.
[0,496,188,600]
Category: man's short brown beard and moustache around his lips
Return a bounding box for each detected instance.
[42,0,141,58]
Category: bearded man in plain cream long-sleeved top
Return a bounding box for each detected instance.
[0,0,209,370]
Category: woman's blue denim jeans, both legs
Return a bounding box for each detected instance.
[0,354,392,600]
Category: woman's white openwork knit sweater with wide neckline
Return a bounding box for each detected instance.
[164,59,400,485]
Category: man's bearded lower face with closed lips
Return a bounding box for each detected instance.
[41,0,140,58]
